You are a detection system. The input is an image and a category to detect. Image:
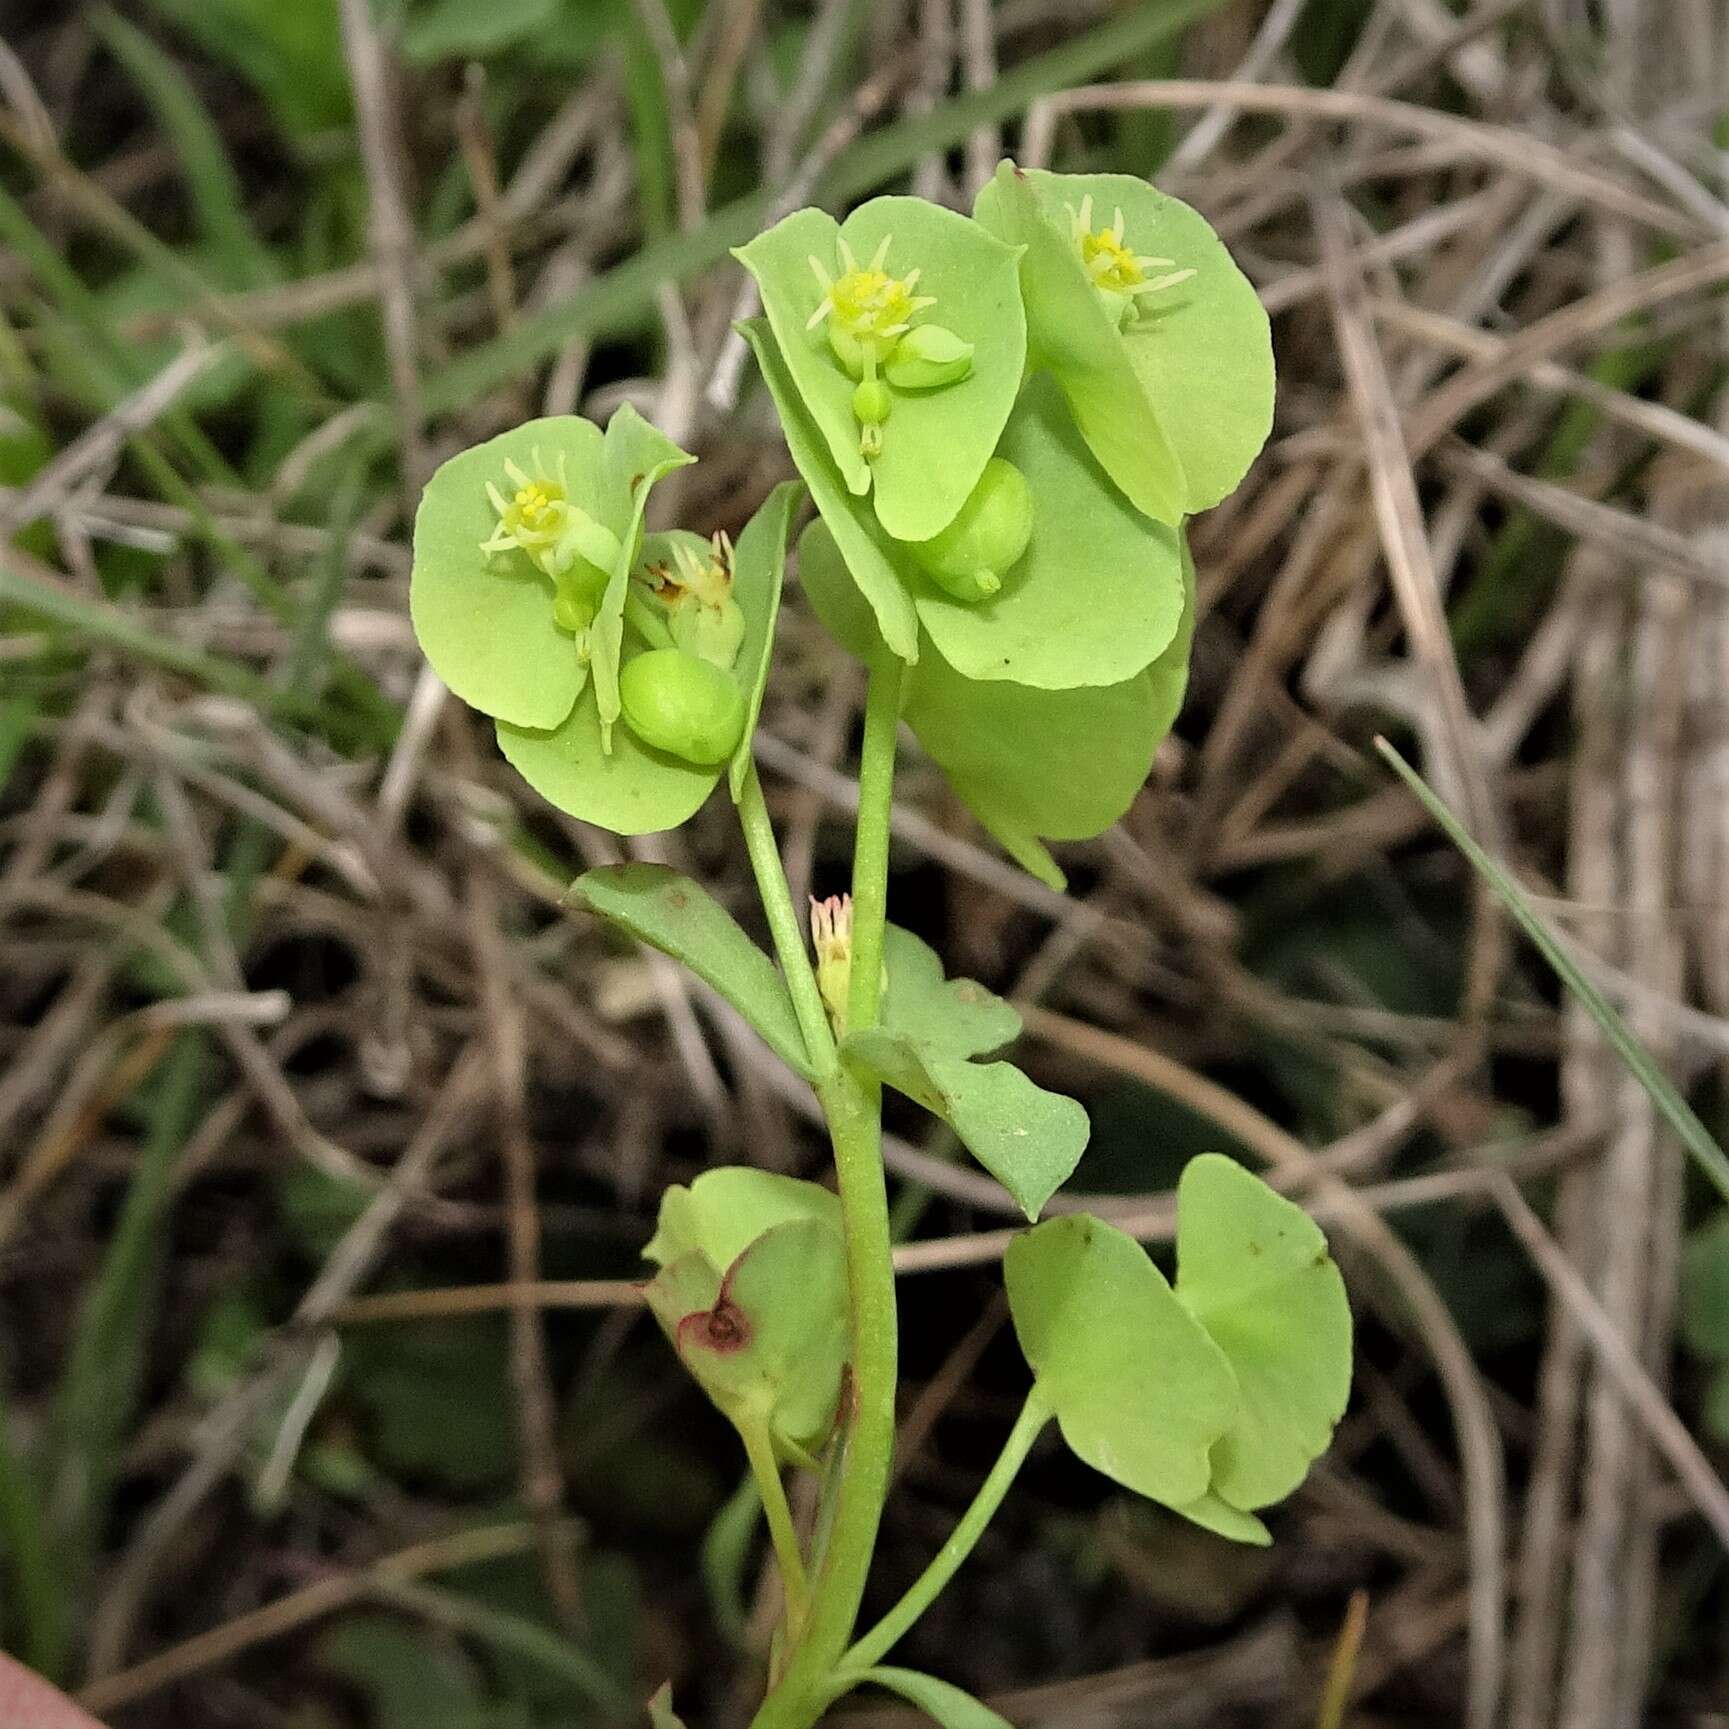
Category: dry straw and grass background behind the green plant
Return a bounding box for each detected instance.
[0,0,1729,1729]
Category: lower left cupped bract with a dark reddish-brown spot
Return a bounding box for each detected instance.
[643,1167,847,1463]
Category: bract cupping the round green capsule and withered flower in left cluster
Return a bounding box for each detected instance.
[498,481,799,835]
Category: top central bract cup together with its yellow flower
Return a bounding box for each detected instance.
[737,197,1027,541]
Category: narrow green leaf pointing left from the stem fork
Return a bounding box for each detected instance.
[571,865,814,1079]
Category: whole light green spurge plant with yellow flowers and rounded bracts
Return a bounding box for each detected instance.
[412,163,1350,1729]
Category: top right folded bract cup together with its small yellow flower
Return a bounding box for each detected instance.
[973,163,1273,522]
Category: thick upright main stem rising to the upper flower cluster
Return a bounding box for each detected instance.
[752,657,904,1729]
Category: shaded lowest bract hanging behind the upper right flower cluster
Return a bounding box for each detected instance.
[799,522,1195,889]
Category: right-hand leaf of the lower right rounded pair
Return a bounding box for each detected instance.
[1177,1153,1350,1511]
